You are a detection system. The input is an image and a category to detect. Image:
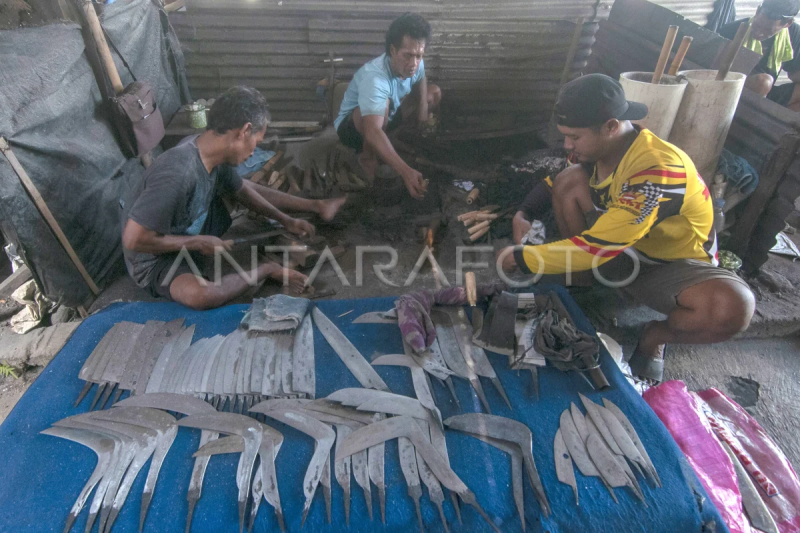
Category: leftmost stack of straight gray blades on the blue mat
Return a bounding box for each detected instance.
[75,319,184,409]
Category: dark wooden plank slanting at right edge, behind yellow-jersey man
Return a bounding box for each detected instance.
[729,133,800,257]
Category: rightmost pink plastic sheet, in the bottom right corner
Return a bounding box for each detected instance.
[698,389,800,533]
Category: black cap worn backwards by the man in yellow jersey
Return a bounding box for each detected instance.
[555,74,647,128]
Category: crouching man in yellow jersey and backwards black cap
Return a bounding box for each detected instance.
[499,74,755,382]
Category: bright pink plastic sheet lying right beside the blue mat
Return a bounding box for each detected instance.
[642,381,753,533]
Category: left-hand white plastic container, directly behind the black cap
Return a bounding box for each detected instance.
[619,72,687,140]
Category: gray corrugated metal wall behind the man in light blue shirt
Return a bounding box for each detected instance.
[170,0,610,130]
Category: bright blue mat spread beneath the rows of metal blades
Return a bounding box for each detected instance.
[0,287,727,533]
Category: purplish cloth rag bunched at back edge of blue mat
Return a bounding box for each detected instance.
[395,281,506,354]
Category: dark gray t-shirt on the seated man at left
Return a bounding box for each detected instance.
[122,135,242,287]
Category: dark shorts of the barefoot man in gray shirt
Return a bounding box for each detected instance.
[147,196,231,300]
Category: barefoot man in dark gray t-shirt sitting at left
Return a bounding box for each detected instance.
[122,87,346,309]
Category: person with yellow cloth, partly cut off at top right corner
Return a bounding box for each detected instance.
[719,0,800,111]
